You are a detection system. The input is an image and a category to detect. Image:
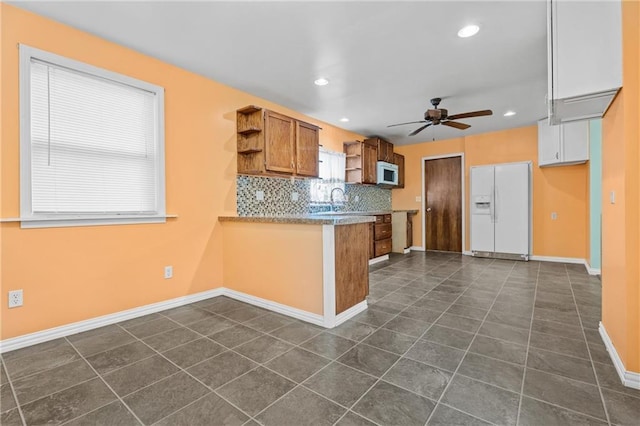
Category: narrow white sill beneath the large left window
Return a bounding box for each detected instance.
[0,214,178,229]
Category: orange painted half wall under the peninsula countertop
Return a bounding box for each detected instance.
[222,222,323,315]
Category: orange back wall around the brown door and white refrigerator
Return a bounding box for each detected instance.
[393,126,589,259]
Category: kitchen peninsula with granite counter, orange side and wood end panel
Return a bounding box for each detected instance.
[219,215,375,328]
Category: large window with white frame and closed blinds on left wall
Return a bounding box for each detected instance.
[20,45,166,227]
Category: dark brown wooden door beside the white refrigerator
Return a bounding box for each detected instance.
[424,157,462,252]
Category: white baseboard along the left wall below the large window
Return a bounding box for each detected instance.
[0,287,225,353]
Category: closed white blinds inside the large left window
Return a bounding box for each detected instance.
[30,59,163,214]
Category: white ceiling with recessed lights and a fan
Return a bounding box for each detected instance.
[11,0,547,144]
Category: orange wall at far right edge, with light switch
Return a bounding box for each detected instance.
[602,1,640,372]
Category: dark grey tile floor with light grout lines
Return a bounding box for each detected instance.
[0,252,640,426]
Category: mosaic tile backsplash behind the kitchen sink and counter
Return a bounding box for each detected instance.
[236,175,391,216]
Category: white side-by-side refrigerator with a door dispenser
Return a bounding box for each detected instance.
[470,162,531,260]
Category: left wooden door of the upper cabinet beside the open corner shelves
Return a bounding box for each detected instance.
[264,111,295,173]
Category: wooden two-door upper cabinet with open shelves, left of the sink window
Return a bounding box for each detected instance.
[236,105,320,177]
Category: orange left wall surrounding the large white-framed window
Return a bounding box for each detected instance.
[0,3,359,339]
